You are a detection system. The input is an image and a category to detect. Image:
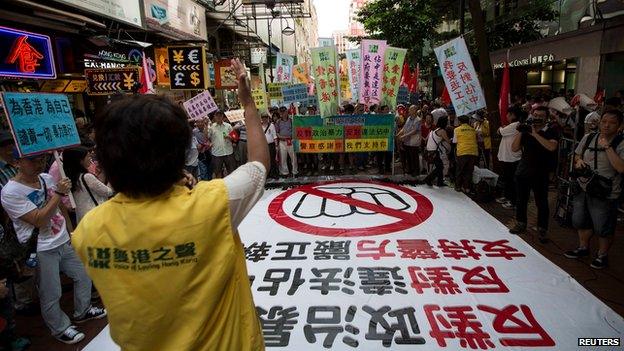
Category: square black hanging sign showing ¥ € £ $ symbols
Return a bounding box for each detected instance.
[167,46,207,90]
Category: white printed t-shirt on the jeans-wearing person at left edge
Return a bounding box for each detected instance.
[2,173,69,251]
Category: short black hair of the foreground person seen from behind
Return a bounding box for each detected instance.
[95,95,191,198]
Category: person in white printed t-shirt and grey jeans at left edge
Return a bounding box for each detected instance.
[2,154,106,344]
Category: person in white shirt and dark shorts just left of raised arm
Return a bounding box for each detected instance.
[208,111,236,178]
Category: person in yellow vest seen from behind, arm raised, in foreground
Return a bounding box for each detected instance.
[72,59,270,351]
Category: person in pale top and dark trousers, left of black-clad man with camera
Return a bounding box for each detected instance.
[496,106,527,210]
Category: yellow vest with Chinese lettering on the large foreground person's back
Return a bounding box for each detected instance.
[72,180,264,351]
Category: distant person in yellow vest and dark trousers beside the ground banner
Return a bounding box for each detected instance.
[453,116,479,194]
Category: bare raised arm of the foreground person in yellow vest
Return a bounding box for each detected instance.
[232,59,271,169]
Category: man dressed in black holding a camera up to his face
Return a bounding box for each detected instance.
[509,106,559,243]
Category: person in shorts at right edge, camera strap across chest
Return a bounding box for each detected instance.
[565,110,624,269]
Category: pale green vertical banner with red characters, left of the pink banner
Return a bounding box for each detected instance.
[311,46,340,117]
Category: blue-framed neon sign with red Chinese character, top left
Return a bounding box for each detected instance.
[0,27,56,79]
